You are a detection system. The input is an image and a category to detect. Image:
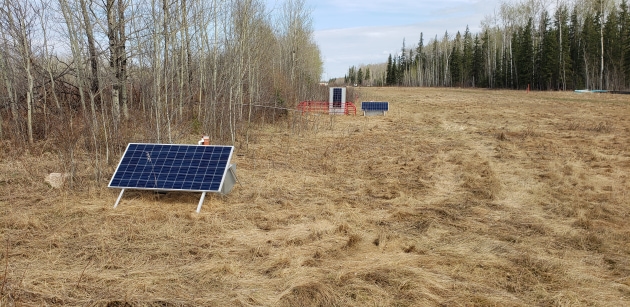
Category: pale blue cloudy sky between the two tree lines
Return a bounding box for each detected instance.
[267,0,500,80]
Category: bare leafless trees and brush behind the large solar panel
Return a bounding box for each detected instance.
[0,0,323,182]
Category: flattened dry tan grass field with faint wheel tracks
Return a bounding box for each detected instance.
[0,88,630,306]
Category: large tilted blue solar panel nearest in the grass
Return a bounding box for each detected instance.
[108,143,234,192]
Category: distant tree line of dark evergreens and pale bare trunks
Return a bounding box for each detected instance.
[346,0,630,90]
